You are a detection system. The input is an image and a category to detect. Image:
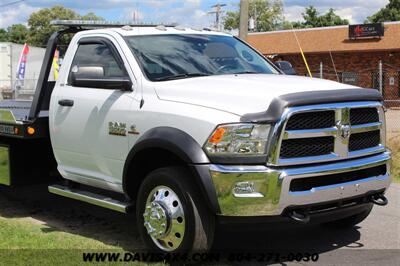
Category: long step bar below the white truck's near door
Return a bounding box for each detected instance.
[49,184,131,213]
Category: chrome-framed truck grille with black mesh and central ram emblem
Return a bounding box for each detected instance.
[268,102,386,166]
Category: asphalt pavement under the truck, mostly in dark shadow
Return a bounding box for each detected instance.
[0,184,400,266]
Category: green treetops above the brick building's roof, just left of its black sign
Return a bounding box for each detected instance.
[292,6,349,28]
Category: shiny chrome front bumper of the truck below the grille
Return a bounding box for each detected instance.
[210,151,390,216]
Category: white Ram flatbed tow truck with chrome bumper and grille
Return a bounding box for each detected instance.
[0,22,390,253]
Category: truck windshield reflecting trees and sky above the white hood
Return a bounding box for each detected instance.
[126,34,279,81]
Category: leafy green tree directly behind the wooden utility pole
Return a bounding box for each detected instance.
[223,0,284,31]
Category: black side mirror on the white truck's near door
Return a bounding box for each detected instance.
[71,66,132,91]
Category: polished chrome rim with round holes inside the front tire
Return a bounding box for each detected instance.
[143,186,185,251]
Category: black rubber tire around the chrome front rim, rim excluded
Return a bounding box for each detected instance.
[136,167,215,253]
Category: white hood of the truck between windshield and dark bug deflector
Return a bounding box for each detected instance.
[155,74,357,116]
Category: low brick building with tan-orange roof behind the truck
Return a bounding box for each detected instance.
[247,22,400,106]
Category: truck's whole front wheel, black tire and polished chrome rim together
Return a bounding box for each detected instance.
[136,167,215,253]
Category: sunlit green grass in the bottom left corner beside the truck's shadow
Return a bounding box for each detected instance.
[0,217,128,266]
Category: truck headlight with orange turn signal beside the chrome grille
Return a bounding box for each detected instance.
[204,124,271,156]
